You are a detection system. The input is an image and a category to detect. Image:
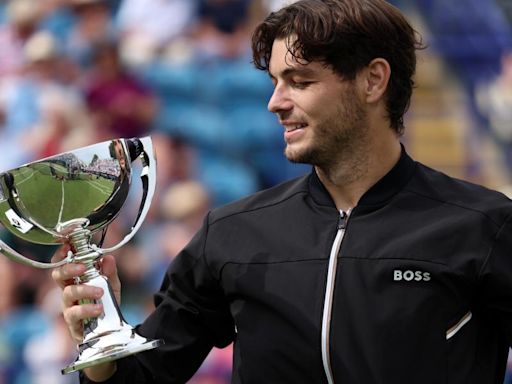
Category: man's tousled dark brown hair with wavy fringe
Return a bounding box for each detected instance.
[252,0,424,135]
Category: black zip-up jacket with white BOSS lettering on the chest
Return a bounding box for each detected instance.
[83,148,512,384]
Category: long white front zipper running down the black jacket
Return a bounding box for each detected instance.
[322,210,350,384]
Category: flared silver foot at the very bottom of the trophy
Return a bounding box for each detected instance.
[61,329,164,375]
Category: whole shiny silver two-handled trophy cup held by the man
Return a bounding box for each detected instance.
[0,137,163,373]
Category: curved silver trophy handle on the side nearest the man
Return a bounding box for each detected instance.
[95,136,156,254]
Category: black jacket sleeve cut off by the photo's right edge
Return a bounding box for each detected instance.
[477,214,512,346]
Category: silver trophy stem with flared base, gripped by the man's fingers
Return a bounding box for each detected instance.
[62,224,163,374]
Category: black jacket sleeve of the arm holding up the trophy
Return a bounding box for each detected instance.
[81,213,235,383]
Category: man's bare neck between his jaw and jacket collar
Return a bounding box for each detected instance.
[315,139,401,211]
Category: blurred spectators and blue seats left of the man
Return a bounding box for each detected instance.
[0,0,300,384]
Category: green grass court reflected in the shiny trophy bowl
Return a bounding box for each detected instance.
[0,163,115,243]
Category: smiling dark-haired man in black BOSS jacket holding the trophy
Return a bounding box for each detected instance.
[53,0,512,384]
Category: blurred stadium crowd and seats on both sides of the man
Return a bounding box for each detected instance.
[0,0,512,384]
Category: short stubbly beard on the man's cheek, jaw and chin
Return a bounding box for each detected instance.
[284,87,369,173]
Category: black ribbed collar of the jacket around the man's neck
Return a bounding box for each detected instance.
[309,145,416,207]
